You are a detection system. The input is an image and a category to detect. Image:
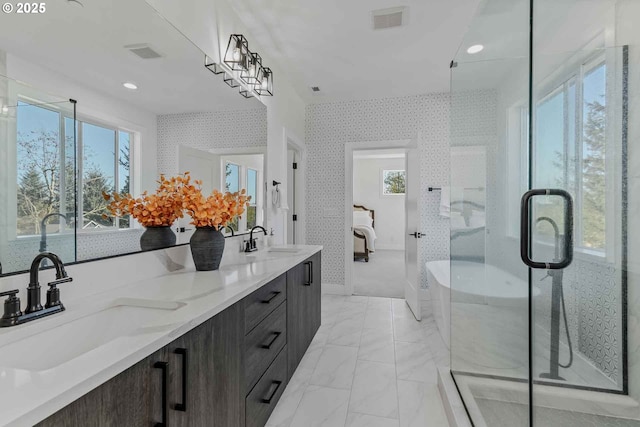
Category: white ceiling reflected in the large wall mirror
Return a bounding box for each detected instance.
[0,0,262,114]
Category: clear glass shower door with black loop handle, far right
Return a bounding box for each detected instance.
[528,0,640,427]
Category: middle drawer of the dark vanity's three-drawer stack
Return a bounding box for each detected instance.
[244,304,287,392]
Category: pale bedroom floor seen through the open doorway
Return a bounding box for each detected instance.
[352,249,404,298]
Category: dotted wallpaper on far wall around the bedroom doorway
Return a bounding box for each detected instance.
[306,91,495,288]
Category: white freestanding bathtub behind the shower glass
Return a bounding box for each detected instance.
[426,260,540,358]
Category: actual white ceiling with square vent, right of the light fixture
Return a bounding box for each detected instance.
[228,0,480,102]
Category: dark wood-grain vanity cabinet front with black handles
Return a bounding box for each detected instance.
[38,253,321,427]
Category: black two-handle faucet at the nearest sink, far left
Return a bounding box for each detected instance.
[0,252,73,328]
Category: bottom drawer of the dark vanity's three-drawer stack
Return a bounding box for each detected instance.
[245,347,287,427]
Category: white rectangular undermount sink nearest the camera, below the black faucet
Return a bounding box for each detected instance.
[0,298,185,371]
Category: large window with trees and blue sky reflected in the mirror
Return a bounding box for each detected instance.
[16,101,132,236]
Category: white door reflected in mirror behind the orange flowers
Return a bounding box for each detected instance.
[176,145,222,243]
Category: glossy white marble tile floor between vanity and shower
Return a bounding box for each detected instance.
[267,295,449,427]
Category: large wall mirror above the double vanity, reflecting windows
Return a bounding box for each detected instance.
[0,0,267,274]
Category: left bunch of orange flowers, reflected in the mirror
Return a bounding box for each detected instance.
[102,172,190,227]
